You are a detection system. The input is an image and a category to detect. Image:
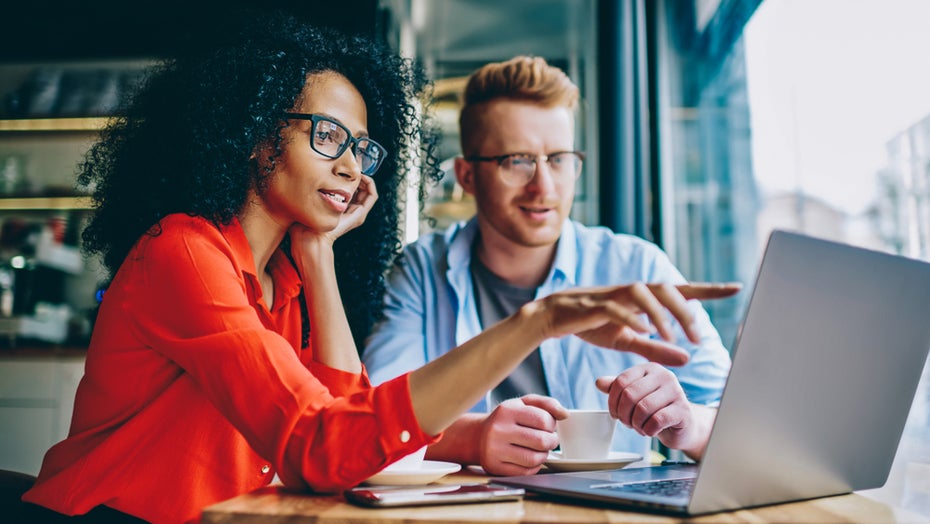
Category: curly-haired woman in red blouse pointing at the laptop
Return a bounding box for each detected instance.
[23,8,732,522]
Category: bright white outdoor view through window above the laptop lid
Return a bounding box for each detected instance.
[744,0,930,258]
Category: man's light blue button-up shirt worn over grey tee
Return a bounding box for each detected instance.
[362,219,730,456]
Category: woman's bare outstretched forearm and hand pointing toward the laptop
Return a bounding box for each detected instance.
[410,283,739,438]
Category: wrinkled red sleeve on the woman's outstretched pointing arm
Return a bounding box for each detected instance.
[124,224,434,491]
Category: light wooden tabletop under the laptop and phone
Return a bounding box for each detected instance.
[202,472,930,524]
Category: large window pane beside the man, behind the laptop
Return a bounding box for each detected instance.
[654,0,930,515]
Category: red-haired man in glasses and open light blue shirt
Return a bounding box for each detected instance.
[363,56,730,475]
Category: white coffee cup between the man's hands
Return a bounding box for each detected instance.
[556,409,617,460]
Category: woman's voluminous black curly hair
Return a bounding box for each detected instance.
[78,8,439,347]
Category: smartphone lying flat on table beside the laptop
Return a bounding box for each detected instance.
[344,483,524,508]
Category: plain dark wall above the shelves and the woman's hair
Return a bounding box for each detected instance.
[0,0,383,62]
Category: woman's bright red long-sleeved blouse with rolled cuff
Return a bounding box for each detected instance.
[23,214,438,522]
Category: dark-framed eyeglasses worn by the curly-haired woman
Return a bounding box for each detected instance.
[284,113,387,176]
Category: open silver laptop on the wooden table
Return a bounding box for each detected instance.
[495,231,930,515]
